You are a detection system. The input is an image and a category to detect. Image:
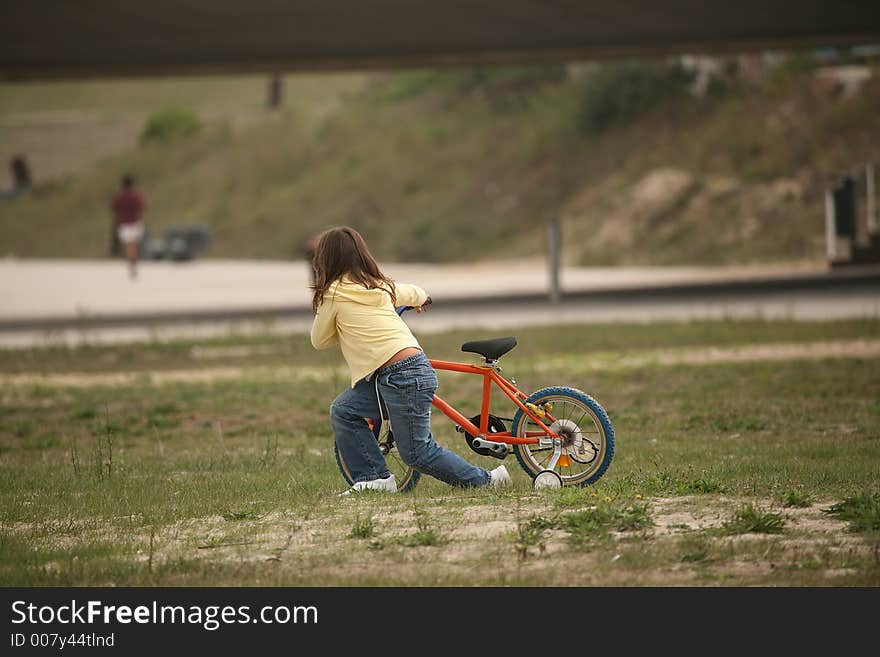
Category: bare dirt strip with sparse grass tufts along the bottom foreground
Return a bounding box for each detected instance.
[6,495,875,586]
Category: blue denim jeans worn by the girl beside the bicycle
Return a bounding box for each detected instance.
[330,352,489,487]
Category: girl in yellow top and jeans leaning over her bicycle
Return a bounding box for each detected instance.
[311,226,510,494]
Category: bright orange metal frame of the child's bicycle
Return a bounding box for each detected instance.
[429,359,558,445]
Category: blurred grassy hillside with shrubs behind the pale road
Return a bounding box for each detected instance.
[0,53,880,265]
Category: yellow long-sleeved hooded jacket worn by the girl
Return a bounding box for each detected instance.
[311,276,428,388]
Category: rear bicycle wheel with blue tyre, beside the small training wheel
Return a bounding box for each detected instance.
[511,386,614,486]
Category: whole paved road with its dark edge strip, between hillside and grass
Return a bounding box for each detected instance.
[0,259,880,347]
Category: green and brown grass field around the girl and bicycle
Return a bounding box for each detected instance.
[0,319,880,586]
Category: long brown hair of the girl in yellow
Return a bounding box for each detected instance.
[309,226,397,312]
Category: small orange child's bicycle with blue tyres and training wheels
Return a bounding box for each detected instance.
[335,298,614,491]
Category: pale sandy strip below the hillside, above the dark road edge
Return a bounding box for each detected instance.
[0,258,860,322]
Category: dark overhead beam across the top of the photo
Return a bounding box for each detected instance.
[0,0,880,80]
